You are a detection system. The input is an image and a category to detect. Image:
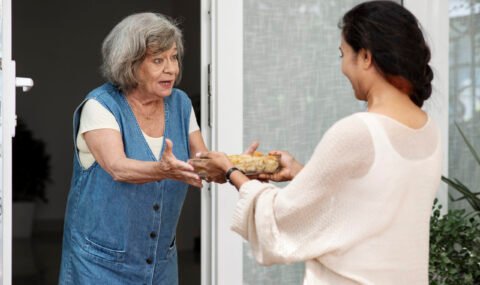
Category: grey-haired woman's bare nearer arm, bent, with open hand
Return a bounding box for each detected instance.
[83,129,202,187]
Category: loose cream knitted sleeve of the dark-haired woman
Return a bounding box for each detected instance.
[232,115,374,265]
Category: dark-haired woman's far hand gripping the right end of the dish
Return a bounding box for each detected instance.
[258,150,303,182]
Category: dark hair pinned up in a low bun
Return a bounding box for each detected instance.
[339,1,433,107]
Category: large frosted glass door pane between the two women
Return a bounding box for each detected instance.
[243,0,400,285]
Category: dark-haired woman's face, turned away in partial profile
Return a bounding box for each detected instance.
[339,37,364,100]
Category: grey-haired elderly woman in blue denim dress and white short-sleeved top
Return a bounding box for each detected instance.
[60,13,207,285]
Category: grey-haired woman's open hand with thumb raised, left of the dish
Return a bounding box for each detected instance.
[158,139,202,188]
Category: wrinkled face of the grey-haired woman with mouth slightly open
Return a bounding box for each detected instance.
[137,44,179,97]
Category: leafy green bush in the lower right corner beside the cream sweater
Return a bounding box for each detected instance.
[429,199,480,285]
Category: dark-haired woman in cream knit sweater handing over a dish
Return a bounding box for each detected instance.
[192,1,442,285]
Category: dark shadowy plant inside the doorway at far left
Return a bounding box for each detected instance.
[12,119,50,202]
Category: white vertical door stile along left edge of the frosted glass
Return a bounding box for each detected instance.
[211,0,244,285]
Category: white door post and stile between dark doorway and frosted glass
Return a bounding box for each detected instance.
[201,0,243,285]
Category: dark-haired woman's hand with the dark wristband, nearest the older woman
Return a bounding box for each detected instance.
[189,151,233,183]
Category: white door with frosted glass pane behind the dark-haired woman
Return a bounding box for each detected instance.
[208,0,448,285]
